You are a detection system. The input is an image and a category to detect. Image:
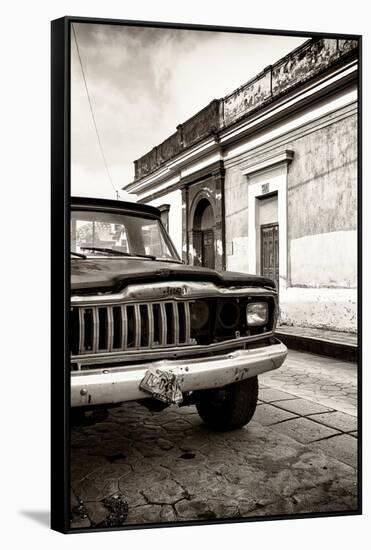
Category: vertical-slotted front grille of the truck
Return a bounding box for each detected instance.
[70,301,193,355]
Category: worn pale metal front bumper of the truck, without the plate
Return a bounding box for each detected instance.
[71,340,287,407]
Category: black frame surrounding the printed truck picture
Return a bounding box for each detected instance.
[51,16,362,533]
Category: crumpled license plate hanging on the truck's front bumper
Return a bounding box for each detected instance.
[139,369,183,405]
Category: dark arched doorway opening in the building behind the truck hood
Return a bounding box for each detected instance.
[193,198,215,269]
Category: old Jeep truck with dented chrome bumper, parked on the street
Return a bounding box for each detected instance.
[69,198,287,430]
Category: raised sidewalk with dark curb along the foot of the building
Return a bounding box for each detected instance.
[276,325,358,362]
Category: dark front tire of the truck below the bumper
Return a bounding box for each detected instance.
[196,376,259,431]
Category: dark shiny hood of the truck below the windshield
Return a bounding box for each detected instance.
[71,257,275,294]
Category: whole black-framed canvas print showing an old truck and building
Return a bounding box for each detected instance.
[52,17,361,533]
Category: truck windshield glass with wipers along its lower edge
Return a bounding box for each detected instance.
[71,210,180,261]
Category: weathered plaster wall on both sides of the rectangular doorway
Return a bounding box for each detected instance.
[225,114,357,332]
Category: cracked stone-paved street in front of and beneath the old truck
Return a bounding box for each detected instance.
[71,351,357,528]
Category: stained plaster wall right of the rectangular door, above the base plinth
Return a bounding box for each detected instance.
[288,115,357,288]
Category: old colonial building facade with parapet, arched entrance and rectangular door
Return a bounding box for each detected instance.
[124,39,358,332]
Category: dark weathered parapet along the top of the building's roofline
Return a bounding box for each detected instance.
[134,38,358,185]
